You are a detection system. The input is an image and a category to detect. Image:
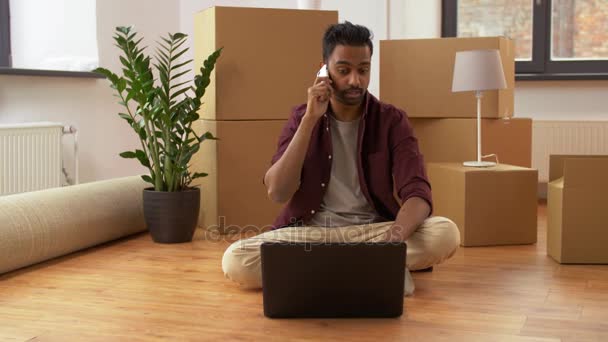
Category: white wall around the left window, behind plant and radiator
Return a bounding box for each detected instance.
[0,0,179,182]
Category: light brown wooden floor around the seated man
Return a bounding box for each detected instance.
[0,205,608,342]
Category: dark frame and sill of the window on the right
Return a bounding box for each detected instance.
[441,0,608,80]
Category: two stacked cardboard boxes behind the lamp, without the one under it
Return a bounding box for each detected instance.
[380,37,532,167]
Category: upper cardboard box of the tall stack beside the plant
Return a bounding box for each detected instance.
[194,7,338,120]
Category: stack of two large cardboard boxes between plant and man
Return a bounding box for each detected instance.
[192,7,338,232]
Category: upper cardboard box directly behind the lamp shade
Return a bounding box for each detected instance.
[380,37,515,118]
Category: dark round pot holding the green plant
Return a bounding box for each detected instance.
[144,188,201,243]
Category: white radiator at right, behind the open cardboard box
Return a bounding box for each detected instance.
[532,121,608,183]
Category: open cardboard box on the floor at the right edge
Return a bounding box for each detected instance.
[547,155,608,264]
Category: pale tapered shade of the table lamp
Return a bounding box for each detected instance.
[452,50,507,92]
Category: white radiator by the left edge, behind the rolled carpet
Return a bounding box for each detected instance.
[0,122,63,196]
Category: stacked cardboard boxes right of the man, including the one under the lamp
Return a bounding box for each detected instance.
[380,37,538,246]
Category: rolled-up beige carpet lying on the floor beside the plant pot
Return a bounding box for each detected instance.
[0,176,147,274]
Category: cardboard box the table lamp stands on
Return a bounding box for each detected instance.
[427,163,538,246]
